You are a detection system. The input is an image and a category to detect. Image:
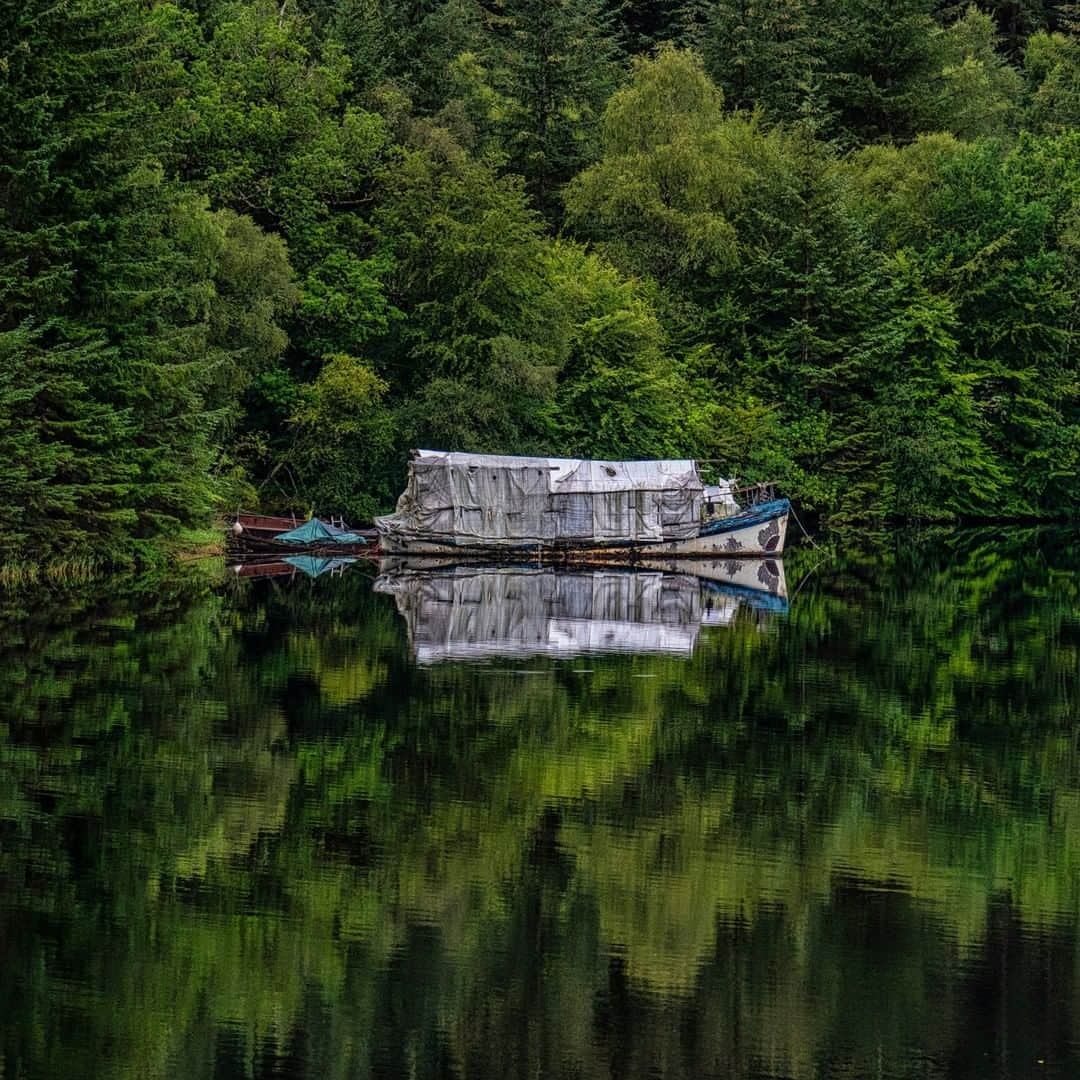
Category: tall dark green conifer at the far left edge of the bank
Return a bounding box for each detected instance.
[0,0,225,557]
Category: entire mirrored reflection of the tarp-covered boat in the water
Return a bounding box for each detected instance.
[375,558,787,664]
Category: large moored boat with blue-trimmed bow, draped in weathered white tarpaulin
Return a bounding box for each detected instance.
[376,450,791,558]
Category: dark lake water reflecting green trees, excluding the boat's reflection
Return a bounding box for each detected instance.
[0,532,1080,1080]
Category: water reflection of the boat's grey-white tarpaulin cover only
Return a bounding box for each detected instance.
[375,567,704,664]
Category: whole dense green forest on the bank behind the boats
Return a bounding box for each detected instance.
[0,0,1080,563]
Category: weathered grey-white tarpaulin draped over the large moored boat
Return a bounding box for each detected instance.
[376,450,703,546]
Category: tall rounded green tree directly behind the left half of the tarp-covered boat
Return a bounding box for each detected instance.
[378,132,561,449]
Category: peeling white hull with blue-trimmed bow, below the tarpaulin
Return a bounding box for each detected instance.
[380,499,789,561]
